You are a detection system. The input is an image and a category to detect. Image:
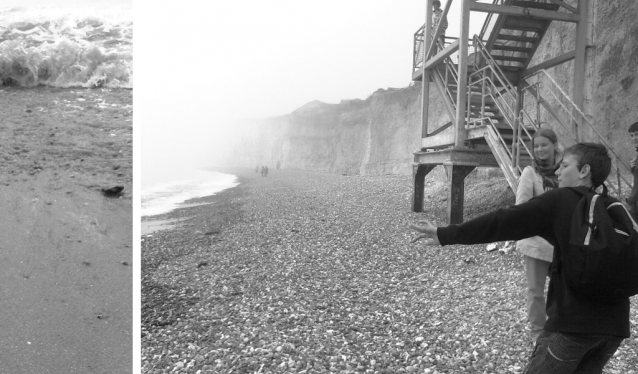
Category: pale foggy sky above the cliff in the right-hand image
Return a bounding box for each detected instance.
[134,0,484,184]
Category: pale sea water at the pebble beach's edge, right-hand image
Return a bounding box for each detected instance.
[142,169,238,216]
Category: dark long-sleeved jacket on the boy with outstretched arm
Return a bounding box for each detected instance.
[437,188,629,338]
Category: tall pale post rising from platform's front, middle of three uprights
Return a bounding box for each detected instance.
[454,0,471,148]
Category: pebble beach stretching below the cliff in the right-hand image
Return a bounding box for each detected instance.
[142,168,638,373]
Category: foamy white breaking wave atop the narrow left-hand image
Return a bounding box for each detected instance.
[0,7,133,88]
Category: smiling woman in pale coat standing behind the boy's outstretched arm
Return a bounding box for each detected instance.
[516,129,561,342]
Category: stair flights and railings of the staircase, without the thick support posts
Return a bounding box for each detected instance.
[415,0,632,196]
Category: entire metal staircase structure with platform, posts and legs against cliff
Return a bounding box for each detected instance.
[412,0,632,223]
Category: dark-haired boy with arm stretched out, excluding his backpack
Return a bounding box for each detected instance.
[410,143,629,374]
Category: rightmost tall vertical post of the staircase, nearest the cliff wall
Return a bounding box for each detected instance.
[572,0,589,141]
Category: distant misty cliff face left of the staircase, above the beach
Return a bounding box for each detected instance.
[220,84,449,174]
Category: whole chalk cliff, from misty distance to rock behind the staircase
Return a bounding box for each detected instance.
[216,1,638,174]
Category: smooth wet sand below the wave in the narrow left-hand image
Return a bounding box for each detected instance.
[0,87,134,374]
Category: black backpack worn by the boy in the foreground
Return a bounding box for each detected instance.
[560,185,638,304]
